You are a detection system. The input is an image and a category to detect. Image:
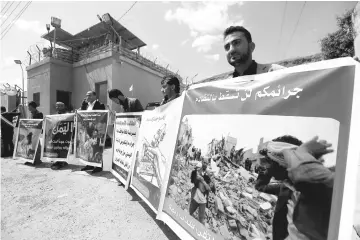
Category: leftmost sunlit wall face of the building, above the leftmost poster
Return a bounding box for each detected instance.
[26,58,52,116]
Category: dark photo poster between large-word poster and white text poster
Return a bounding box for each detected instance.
[75,110,109,167]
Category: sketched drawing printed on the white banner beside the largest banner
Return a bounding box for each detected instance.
[132,115,171,209]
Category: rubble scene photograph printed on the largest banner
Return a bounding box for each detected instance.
[163,114,340,240]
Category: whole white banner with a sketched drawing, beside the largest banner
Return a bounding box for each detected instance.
[130,96,184,213]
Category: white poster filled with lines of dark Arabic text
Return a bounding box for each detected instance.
[111,113,142,189]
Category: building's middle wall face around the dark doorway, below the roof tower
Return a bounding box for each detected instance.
[72,55,113,109]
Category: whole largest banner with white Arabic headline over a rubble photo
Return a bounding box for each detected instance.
[157,59,358,239]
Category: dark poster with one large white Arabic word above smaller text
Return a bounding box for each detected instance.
[41,113,75,161]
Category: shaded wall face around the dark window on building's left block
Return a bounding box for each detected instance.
[49,59,76,114]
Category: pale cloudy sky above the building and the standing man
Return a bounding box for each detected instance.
[0,1,356,88]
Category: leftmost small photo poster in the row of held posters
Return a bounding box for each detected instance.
[13,119,43,163]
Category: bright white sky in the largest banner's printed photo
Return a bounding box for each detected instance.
[184,115,340,167]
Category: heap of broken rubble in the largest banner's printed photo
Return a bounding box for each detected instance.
[169,155,277,240]
